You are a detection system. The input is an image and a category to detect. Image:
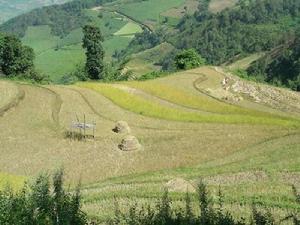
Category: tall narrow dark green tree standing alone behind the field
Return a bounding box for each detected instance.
[83,25,104,80]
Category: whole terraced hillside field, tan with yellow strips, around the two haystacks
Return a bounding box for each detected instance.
[0,67,300,221]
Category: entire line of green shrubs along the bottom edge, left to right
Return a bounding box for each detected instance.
[0,170,300,225]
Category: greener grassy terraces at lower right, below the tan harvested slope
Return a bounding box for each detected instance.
[83,133,300,221]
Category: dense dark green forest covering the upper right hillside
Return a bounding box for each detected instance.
[170,0,300,65]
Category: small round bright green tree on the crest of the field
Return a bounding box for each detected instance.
[175,49,205,70]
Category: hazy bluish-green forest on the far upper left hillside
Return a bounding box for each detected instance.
[0,0,113,37]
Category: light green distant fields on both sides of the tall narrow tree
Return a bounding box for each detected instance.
[22,10,141,82]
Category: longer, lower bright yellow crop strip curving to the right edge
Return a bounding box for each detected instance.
[77,83,299,127]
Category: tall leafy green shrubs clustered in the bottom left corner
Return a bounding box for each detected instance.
[0,171,87,225]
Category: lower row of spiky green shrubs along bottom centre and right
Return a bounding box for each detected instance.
[110,181,300,225]
